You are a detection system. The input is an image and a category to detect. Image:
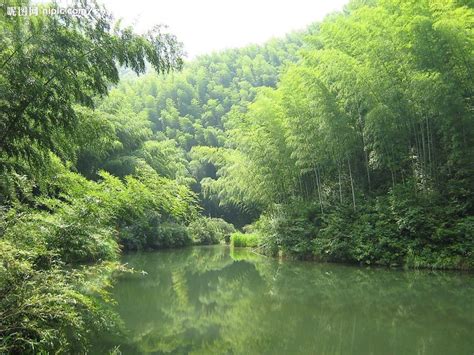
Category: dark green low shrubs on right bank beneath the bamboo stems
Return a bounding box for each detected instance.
[313,182,474,269]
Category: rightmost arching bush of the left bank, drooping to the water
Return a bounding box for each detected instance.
[103,165,196,250]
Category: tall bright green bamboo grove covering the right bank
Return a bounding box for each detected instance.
[197,1,474,268]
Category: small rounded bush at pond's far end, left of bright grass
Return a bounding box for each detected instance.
[188,217,235,245]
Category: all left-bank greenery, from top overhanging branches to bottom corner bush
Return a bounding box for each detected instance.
[0,0,197,354]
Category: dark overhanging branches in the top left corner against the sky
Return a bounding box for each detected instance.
[0,0,182,166]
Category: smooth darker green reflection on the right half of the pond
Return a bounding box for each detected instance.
[250,262,474,354]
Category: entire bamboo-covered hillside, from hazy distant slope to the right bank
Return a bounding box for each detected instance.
[103,1,474,268]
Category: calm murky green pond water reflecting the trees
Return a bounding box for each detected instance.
[108,246,474,355]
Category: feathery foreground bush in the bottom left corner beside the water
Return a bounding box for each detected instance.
[0,240,120,354]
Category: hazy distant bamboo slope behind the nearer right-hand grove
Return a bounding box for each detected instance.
[84,31,310,222]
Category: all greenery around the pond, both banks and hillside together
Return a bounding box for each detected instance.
[0,0,474,354]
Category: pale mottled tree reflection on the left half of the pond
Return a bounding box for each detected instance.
[116,248,261,353]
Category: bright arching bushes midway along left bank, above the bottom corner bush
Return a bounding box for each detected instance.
[32,164,196,254]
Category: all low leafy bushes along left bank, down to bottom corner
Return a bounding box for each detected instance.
[0,160,199,353]
